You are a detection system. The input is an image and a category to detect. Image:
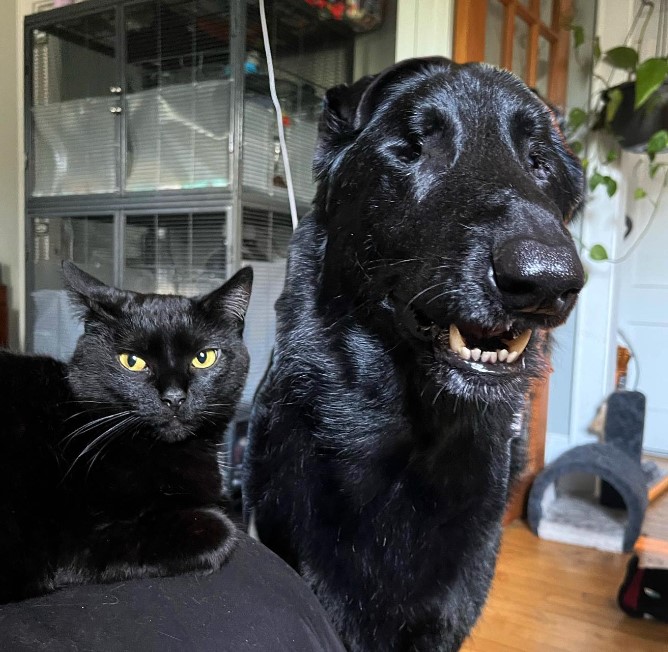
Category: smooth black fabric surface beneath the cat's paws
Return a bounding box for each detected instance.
[0,535,344,652]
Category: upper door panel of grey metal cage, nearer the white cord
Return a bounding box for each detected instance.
[125,0,232,191]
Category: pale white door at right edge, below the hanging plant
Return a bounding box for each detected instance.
[616,155,668,455]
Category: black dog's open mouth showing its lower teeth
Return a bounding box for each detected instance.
[392,294,532,371]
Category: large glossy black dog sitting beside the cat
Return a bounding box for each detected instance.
[245,58,583,652]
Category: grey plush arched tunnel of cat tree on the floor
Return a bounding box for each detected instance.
[528,443,648,552]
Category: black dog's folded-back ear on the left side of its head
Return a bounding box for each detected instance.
[313,57,453,179]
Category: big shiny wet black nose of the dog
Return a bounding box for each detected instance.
[493,239,584,316]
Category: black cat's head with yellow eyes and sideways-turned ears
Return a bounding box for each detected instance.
[63,262,253,442]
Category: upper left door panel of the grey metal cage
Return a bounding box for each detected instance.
[31,10,119,197]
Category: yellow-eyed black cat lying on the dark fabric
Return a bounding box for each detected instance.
[0,263,252,602]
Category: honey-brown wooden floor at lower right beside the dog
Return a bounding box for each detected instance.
[462,522,668,652]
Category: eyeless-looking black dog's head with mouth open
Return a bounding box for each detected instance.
[314,57,584,399]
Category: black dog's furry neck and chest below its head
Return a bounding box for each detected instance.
[246,216,515,649]
